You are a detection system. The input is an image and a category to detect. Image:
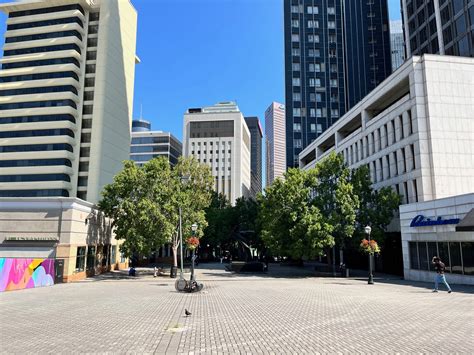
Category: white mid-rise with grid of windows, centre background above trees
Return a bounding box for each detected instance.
[183,102,251,204]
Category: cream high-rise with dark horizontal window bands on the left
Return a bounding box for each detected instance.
[0,0,137,202]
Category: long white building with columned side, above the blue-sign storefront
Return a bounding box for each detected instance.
[300,55,474,204]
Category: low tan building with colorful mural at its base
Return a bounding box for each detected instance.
[0,197,128,291]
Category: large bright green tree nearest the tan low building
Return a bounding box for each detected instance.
[98,158,174,257]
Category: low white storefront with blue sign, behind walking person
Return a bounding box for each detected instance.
[400,193,474,287]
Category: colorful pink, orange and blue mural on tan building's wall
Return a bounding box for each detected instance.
[0,258,54,292]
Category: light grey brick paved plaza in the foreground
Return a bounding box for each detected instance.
[0,264,474,354]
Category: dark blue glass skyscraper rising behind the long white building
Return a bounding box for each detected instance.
[284,0,391,167]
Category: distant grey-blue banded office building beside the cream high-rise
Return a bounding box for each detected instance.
[130,119,183,166]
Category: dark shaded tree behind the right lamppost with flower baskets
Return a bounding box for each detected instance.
[351,165,401,244]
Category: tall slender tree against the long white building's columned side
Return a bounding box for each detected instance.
[313,153,359,263]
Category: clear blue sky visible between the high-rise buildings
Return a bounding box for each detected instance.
[0,0,400,139]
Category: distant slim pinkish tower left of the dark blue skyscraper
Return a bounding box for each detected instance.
[265,102,286,186]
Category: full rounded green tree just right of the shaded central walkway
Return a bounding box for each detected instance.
[258,169,334,260]
